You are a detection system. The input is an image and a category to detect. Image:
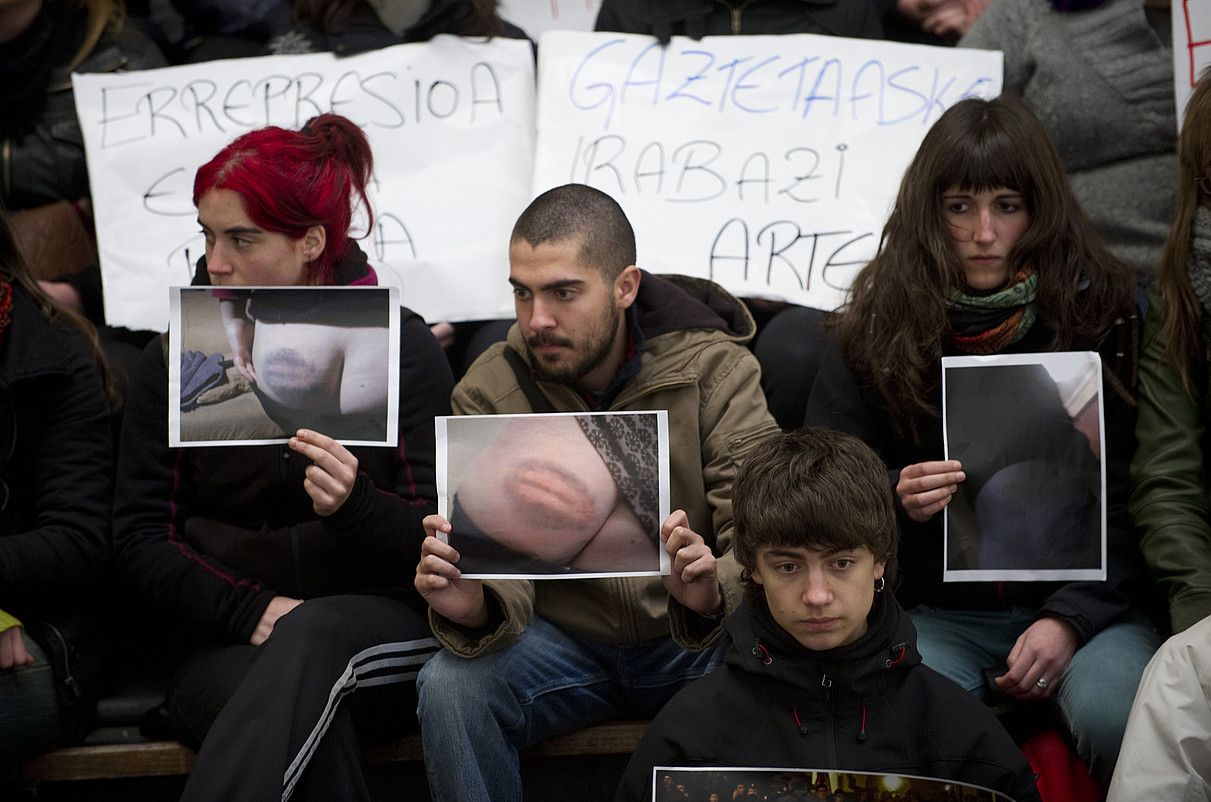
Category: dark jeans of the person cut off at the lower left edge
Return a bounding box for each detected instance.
[0,632,65,764]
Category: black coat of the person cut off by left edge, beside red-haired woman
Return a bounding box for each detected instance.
[0,326,114,614]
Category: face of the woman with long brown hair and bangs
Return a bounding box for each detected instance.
[942,187,1031,294]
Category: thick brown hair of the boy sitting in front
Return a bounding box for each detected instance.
[731,428,899,595]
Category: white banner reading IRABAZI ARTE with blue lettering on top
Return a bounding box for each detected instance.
[534,31,1001,309]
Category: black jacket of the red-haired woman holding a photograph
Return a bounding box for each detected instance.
[114,246,453,643]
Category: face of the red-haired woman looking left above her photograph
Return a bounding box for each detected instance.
[197,189,323,286]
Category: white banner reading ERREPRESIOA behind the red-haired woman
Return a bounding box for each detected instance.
[73,36,534,330]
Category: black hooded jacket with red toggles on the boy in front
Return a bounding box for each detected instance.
[615,591,1039,802]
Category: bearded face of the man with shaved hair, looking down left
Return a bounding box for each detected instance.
[509,239,638,390]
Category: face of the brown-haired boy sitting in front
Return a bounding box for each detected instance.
[752,546,884,652]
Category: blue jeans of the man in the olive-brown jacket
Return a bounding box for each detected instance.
[417,618,725,802]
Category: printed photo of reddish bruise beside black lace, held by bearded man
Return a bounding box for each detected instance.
[438,412,668,578]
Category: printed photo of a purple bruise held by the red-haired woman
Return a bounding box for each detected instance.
[170,287,398,446]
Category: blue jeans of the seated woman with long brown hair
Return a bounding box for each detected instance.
[908,605,1160,789]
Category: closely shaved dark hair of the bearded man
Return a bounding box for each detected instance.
[509,184,635,282]
